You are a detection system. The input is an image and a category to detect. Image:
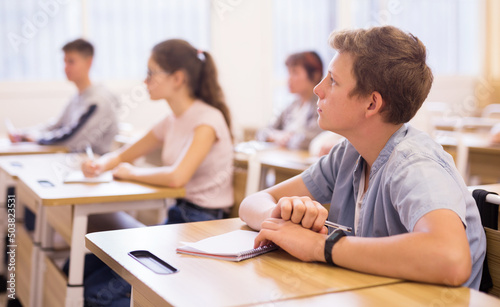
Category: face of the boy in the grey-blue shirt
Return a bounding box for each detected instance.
[314,53,368,137]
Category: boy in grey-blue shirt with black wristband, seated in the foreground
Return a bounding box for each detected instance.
[240,26,486,289]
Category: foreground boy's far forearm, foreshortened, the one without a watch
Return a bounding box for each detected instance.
[239,192,276,230]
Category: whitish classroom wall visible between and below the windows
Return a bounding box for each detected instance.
[0,0,479,140]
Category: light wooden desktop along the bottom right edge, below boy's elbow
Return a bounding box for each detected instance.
[274,282,500,307]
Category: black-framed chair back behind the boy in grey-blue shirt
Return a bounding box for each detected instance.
[472,190,500,297]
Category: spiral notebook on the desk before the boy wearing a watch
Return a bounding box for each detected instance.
[176,230,278,261]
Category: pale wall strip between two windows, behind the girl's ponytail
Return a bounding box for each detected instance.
[211,0,273,139]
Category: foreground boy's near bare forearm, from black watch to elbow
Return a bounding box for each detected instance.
[330,232,471,285]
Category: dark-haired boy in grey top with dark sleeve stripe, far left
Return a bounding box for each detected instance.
[9,39,119,154]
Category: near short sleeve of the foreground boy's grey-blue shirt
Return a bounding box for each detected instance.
[386,154,472,231]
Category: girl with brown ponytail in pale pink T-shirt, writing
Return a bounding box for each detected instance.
[82,39,233,224]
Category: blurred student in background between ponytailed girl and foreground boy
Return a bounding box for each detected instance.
[256,51,323,150]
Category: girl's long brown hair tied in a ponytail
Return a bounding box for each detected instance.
[152,39,231,130]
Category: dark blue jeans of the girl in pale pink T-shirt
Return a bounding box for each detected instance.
[165,198,227,224]
